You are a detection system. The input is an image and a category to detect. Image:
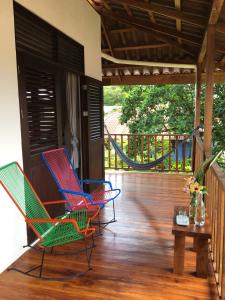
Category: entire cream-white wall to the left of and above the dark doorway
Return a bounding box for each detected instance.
[0,0,101,272]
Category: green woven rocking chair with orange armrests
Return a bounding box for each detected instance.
[0,162,99,280]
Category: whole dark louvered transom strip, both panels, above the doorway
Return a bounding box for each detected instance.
[14,2,84,74]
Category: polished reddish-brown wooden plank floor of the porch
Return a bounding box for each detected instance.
[0,173,217,300]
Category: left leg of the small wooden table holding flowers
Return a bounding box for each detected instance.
[173,235,185,274]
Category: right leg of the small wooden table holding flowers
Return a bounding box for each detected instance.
[196,237,209,277]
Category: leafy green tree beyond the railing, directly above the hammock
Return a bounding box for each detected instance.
[121,84,194,133]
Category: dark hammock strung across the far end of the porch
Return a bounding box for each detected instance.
[104,125,199,170]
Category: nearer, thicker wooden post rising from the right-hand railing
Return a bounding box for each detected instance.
[204,24,215,154]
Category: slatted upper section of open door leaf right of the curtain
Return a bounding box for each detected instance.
[88,82,103,141]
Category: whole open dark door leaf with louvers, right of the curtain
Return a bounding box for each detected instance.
[81,77,105,190]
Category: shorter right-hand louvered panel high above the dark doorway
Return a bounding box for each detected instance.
[58,34,84,74]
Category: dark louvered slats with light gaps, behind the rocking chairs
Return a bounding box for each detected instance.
[24,67,58,155]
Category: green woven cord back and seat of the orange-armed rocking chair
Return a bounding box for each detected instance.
[0,162,88,247]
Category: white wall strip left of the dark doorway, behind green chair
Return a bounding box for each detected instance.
[0,0,26,272]
